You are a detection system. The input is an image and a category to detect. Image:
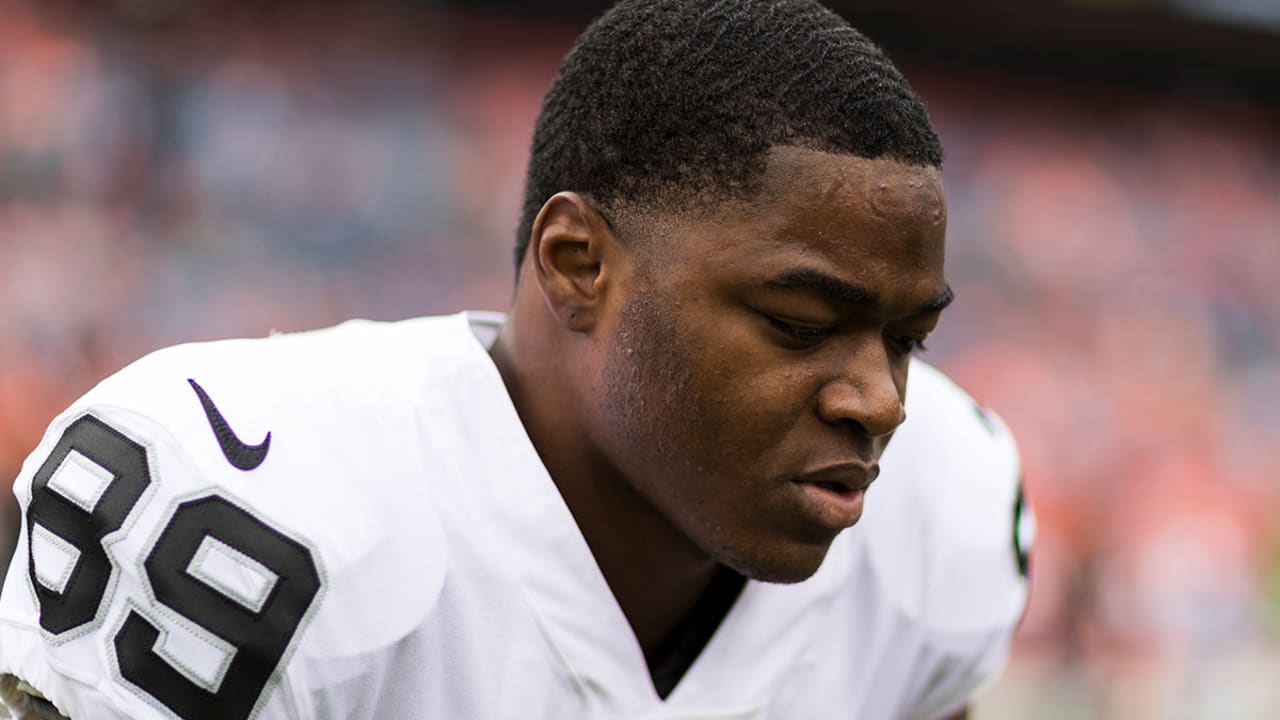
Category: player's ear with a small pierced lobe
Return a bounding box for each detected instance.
[527,192,618,333]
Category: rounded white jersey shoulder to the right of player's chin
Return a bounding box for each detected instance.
[867,361,1029,634]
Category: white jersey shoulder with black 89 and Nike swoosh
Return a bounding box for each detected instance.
[0,318,481,719]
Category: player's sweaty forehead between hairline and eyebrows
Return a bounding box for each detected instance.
[663,147,946,301]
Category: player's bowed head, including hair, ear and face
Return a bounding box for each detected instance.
[512,0,950,582]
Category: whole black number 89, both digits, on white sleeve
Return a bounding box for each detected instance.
[27,415,321,720]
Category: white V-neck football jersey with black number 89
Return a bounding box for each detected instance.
[0,314,1027,720]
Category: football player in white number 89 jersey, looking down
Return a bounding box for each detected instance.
[0,0,1027,720]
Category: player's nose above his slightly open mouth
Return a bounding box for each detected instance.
[818,338,906,438]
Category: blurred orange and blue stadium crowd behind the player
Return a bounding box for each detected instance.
[0,3,1280,719]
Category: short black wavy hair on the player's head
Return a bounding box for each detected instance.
[516,0,942,272]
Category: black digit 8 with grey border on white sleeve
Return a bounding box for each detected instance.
[27,415,151,635]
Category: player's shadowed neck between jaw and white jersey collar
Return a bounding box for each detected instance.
[490,310,718,656]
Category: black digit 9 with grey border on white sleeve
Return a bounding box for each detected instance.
[115,497,320,720]
